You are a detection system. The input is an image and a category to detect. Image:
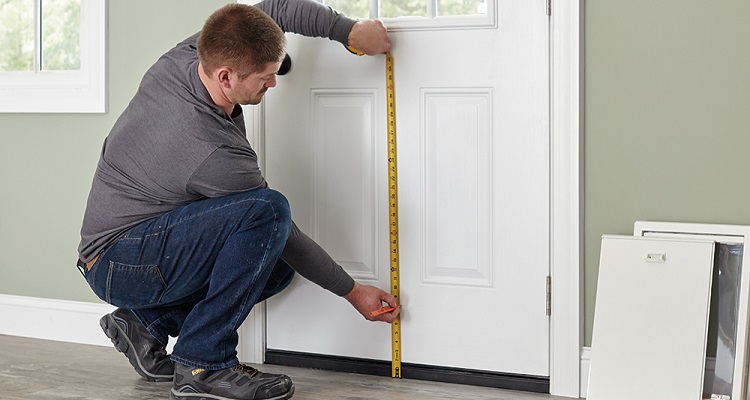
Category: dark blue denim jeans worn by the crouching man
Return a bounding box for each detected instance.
[85,189,294,370]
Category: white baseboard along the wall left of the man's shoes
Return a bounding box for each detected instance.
[0,294,115,346]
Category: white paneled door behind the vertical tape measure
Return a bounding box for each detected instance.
[265,0,549,376]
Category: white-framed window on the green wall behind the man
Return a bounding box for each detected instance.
[0,0,106,113]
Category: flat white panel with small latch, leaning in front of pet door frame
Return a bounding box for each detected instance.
[588,236,714,400]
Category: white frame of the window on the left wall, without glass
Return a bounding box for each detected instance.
[0,0,107,113]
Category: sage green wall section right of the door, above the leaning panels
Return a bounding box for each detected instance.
[584,0,750,345]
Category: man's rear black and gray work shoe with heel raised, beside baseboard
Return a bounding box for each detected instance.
[99,308,174,382]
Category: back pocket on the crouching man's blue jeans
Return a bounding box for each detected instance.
[104,262,167,308]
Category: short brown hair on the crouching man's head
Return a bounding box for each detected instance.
[197,3,286,79]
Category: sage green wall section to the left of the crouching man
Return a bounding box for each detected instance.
[0,0,229,301]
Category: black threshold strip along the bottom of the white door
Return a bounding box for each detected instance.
[266,350,549,393]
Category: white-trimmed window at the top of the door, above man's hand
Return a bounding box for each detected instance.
[322,0,496,30]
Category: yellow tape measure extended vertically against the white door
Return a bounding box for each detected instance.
[385,52,401,378]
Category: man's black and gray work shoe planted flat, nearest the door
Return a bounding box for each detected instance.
[169,363,294,400]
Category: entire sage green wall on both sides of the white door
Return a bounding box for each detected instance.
[0,0,750,345]
